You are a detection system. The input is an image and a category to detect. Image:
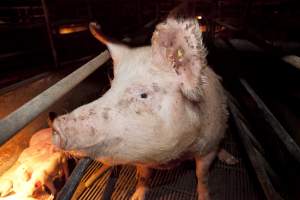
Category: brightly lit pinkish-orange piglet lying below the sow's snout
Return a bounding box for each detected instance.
[0,114,69,199]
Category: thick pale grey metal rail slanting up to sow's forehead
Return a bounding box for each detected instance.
[0,50,110,144]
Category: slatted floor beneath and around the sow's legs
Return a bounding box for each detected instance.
[72,122,265,200]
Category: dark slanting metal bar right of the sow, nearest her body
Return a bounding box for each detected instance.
[229,97,283,200]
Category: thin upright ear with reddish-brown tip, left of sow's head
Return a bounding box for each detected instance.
[89,22,129,63]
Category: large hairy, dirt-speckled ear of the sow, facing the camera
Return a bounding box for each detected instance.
[152,12,207,101]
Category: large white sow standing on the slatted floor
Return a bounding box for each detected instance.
[52,4,228,200]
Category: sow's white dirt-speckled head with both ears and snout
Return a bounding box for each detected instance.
[53,12,216,162]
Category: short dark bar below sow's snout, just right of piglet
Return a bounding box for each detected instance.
[57,158,92,200]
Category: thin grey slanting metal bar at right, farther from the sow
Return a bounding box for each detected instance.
[240,79,300,162]
